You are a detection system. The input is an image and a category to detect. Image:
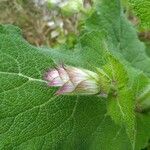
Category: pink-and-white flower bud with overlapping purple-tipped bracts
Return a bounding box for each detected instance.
[45,66,108,95]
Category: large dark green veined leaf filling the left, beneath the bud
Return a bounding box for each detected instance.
[0,25,131,150]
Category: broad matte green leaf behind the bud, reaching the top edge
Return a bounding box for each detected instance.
[81,0,150,76]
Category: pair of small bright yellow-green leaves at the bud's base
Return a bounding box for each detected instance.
[104,57,136,149]
